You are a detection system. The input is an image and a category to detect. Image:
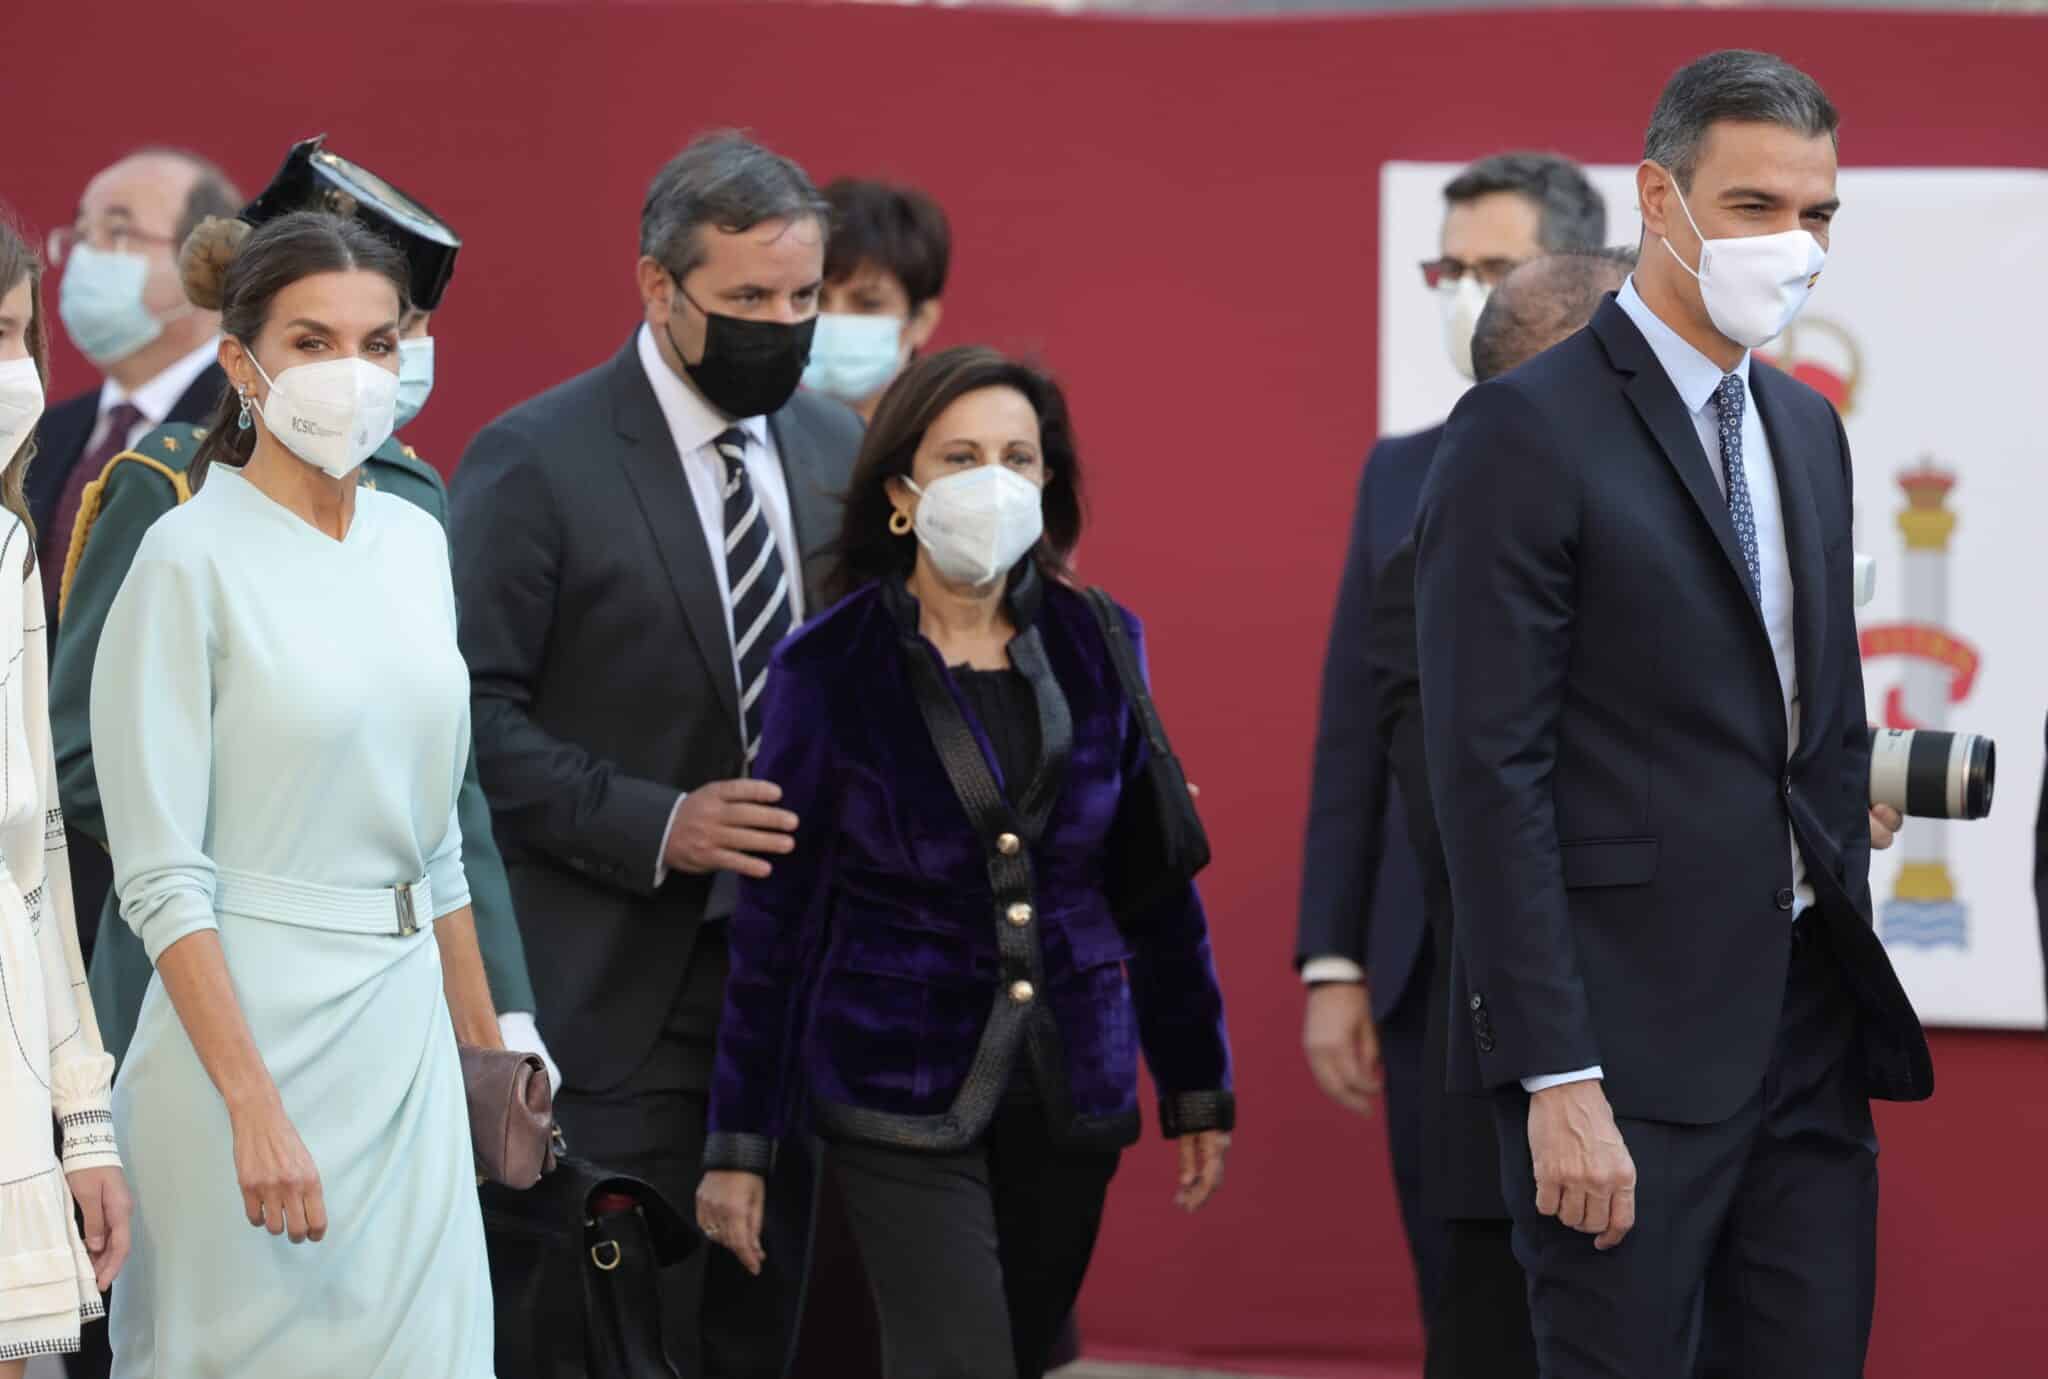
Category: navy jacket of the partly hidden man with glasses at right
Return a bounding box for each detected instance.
[1294,426,1444,1020]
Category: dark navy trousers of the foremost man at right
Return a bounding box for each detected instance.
[1495,916,1878,1379]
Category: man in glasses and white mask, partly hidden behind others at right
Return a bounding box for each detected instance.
[1294,154,1608,1330]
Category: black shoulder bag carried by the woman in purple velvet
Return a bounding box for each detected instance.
[1087,588,1208,922]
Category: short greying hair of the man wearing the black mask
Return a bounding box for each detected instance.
[641,129,831,279]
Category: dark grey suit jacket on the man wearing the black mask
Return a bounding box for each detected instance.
[451,329,860,1090]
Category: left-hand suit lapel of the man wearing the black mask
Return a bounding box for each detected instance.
[610,329,739,723]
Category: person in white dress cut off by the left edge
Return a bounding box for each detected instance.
[0,213,131,1379]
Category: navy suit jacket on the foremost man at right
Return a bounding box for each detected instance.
[1415,297,1933,1125]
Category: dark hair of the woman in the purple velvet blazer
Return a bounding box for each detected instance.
[825,344,1083,600]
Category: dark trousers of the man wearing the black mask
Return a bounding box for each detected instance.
[555,924,817,1379]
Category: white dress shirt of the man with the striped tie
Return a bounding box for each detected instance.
[639,324,803,885]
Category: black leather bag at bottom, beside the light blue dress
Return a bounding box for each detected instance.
[477,1158,698,1379]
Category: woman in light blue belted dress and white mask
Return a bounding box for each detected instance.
[92,213,500,1379]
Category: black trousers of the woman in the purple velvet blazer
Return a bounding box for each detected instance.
[825,1096,1120,1379]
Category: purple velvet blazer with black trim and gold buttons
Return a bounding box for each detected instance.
[705,566,1235,1172]
